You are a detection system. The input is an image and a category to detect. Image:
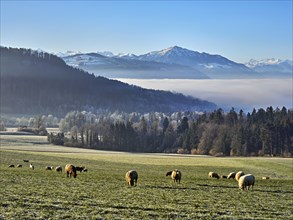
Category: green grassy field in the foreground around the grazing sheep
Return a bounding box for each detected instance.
[0,135,293,219]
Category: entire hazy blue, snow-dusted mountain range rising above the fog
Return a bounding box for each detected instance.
[61,46,292,79]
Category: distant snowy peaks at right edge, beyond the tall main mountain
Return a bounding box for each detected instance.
[245,58,293,78]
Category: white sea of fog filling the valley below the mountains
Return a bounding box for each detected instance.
[116,78,293,112]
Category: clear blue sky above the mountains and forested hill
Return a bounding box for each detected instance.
[0,0,293,63]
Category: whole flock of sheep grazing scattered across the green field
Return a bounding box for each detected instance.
[9,160,260,190]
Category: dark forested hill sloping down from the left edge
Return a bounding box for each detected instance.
[0,47,216,116]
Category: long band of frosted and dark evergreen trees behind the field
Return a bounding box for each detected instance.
[49,107,293,156]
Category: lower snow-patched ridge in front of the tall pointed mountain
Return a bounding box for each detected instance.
[63,53,209,79]
